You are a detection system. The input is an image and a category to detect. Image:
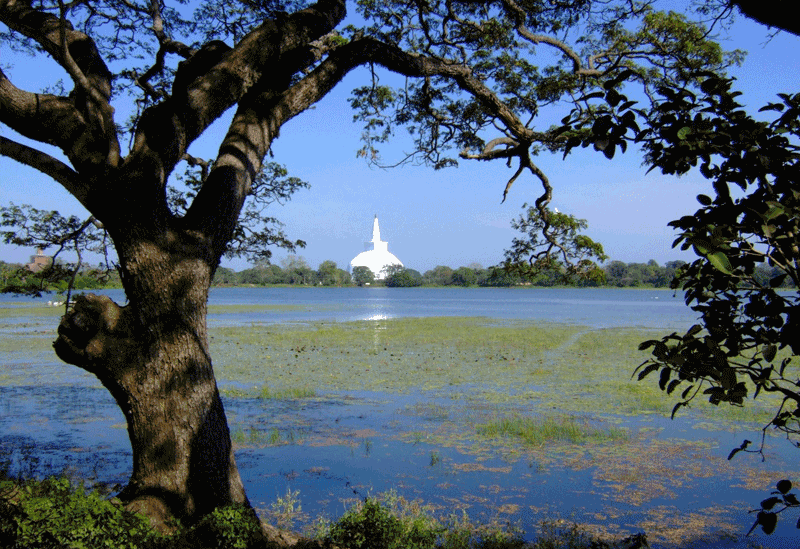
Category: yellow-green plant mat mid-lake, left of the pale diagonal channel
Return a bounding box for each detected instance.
[211,318,580,392]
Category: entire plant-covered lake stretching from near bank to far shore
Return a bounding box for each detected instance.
[0,288,800,547]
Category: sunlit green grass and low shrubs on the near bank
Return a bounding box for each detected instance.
[0,470,632,549]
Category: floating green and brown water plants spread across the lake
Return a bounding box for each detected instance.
[6,308,796,548]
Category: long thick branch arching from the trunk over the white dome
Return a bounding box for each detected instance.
[184,38,552,254]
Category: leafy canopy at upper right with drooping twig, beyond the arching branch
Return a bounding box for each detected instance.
[344,0,742,275]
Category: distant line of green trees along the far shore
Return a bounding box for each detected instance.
[0,255,791,291]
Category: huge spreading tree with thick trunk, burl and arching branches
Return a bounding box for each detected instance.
[0,0,728,525]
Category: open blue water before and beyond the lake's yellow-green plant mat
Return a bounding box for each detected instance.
[0,288,800,547]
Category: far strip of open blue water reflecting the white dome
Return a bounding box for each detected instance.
[42,287,697,329]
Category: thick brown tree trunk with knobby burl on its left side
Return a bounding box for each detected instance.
[54,231,249,527]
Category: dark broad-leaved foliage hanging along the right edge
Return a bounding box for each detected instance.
[624,80,800,450]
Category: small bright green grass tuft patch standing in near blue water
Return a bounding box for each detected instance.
[476,415,628,446]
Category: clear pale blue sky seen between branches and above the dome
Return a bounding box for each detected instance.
[0,3,800,272]
